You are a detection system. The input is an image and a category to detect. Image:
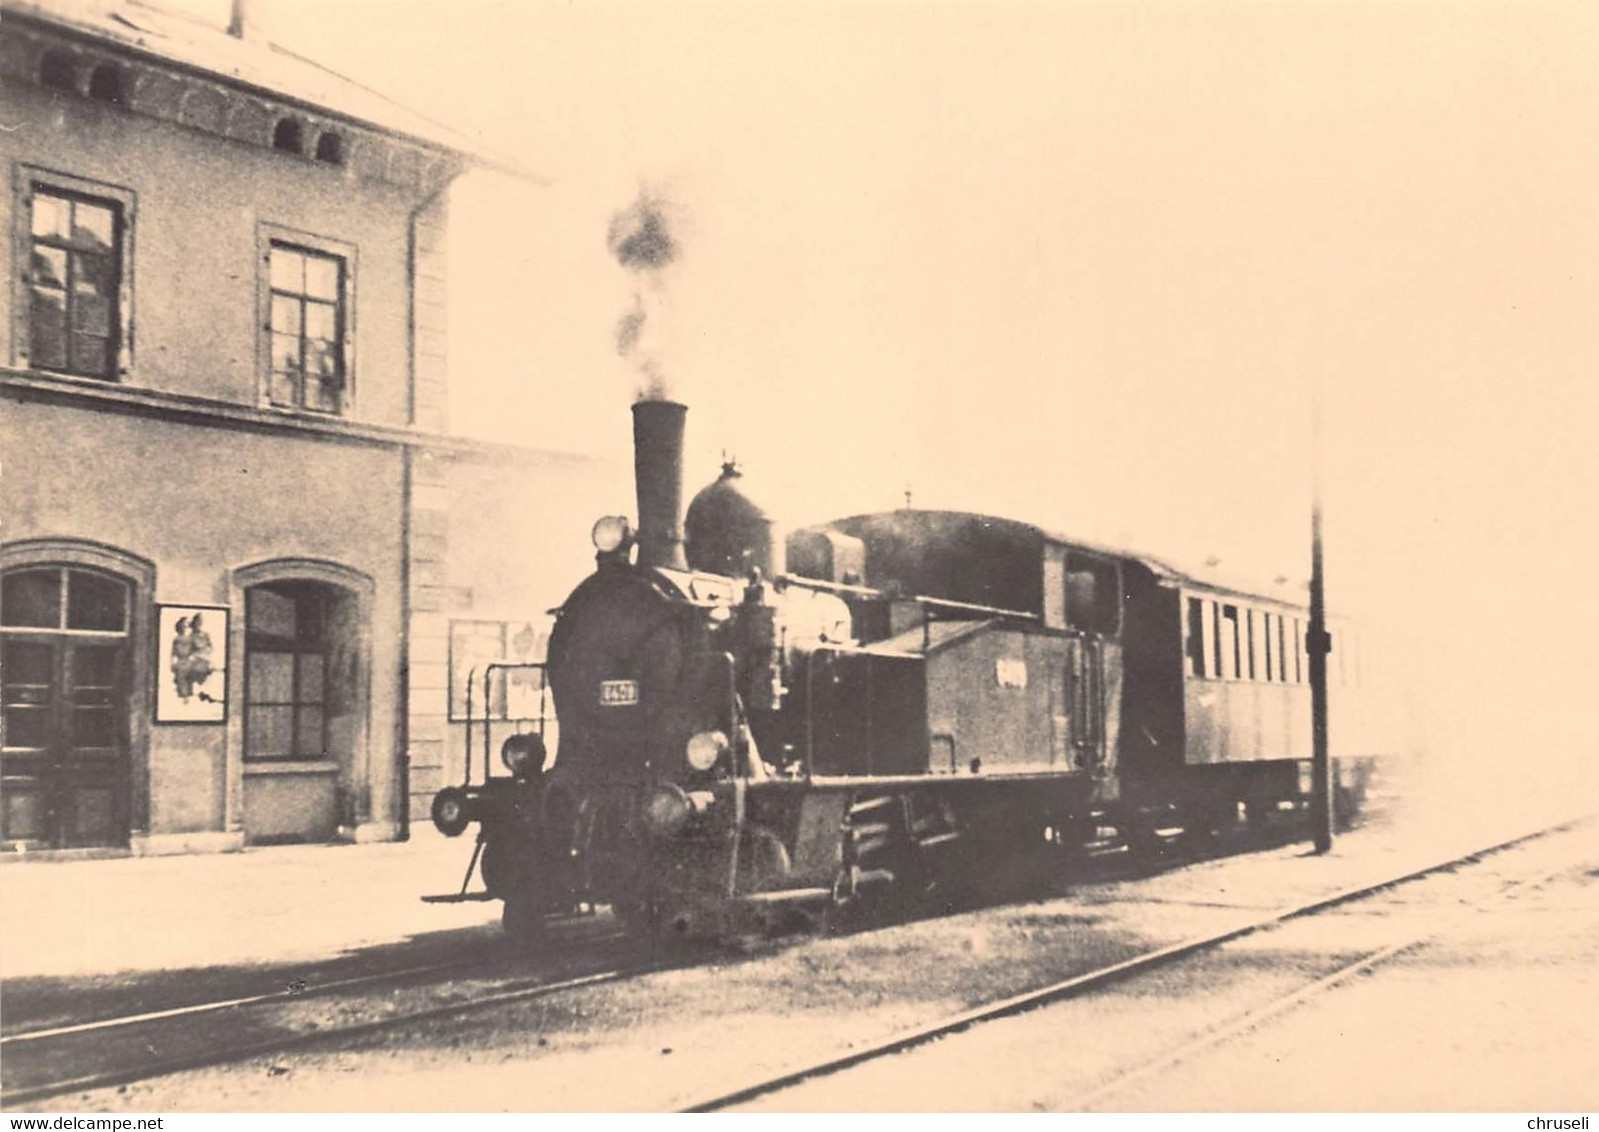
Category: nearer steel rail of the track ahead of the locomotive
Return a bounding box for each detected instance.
[0,940,655,1111]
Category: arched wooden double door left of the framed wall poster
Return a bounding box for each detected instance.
[0,564,133,849]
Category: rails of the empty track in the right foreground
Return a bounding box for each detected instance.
[681,815,1594,1113]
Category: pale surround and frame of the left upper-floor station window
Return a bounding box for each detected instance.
[11,163,138,384]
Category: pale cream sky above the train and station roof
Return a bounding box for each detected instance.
[165,0,1599,783]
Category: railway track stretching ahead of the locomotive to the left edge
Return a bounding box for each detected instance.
[0,932,665,1111]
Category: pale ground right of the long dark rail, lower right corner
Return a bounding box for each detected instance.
[732,825,1599,1111]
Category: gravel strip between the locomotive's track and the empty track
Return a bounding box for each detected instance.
[21,799,1586,1113]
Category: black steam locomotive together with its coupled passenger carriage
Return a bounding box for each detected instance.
[433,400,1375,935]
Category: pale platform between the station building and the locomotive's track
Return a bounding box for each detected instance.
[0,823,499,980]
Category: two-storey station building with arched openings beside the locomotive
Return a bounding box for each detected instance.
[0,0,614,857]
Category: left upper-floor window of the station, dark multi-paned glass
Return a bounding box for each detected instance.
[18,177,131,381]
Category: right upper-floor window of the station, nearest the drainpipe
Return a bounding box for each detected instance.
[267,240,349,414]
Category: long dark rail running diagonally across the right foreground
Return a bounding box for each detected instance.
[680,814,1594,1113]
